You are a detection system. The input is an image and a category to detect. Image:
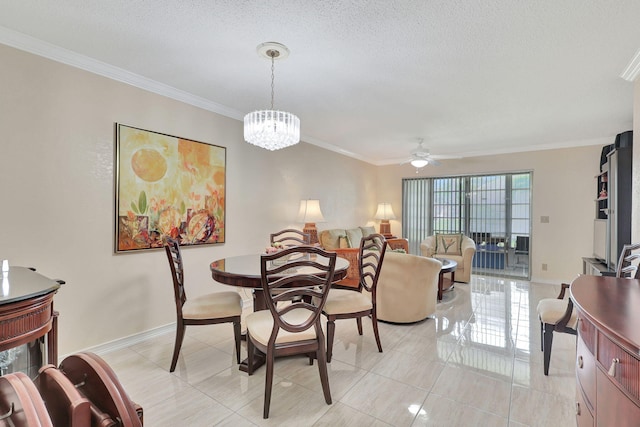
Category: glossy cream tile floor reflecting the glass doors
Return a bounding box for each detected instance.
[101,276,576,427]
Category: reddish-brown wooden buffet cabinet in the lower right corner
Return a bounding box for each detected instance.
[571,276,640,427]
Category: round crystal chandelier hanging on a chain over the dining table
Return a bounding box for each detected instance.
[244,42,300,151]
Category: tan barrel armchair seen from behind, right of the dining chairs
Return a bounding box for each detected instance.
[376,250,442,323]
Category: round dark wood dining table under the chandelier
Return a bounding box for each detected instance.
[210,254,349,372]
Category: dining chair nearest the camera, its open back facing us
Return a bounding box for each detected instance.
[246,246,336,418]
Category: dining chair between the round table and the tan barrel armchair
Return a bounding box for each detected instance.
[322,234,387,362]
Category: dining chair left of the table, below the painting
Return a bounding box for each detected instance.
[165,239,242,372]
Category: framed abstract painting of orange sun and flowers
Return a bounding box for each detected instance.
[115,124,226,252]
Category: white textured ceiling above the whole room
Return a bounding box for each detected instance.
[0,0,640,164]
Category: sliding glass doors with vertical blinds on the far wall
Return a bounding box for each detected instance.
[402,172,532,278]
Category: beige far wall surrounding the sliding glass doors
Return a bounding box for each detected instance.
[378,145,615,283]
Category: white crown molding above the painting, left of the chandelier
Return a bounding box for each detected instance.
[0,26,244,120]
